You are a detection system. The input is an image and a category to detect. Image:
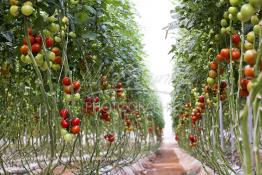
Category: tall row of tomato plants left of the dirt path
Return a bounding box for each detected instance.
[0,0,163,174]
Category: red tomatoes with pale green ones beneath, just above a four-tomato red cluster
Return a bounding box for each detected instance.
[63,77,81,101]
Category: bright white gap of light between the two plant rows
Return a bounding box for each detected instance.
[132,0,174,138]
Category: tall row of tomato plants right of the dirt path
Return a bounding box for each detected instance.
[172,0,262,175]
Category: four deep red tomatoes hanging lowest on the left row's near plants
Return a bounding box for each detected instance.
[59,108,81,137]
